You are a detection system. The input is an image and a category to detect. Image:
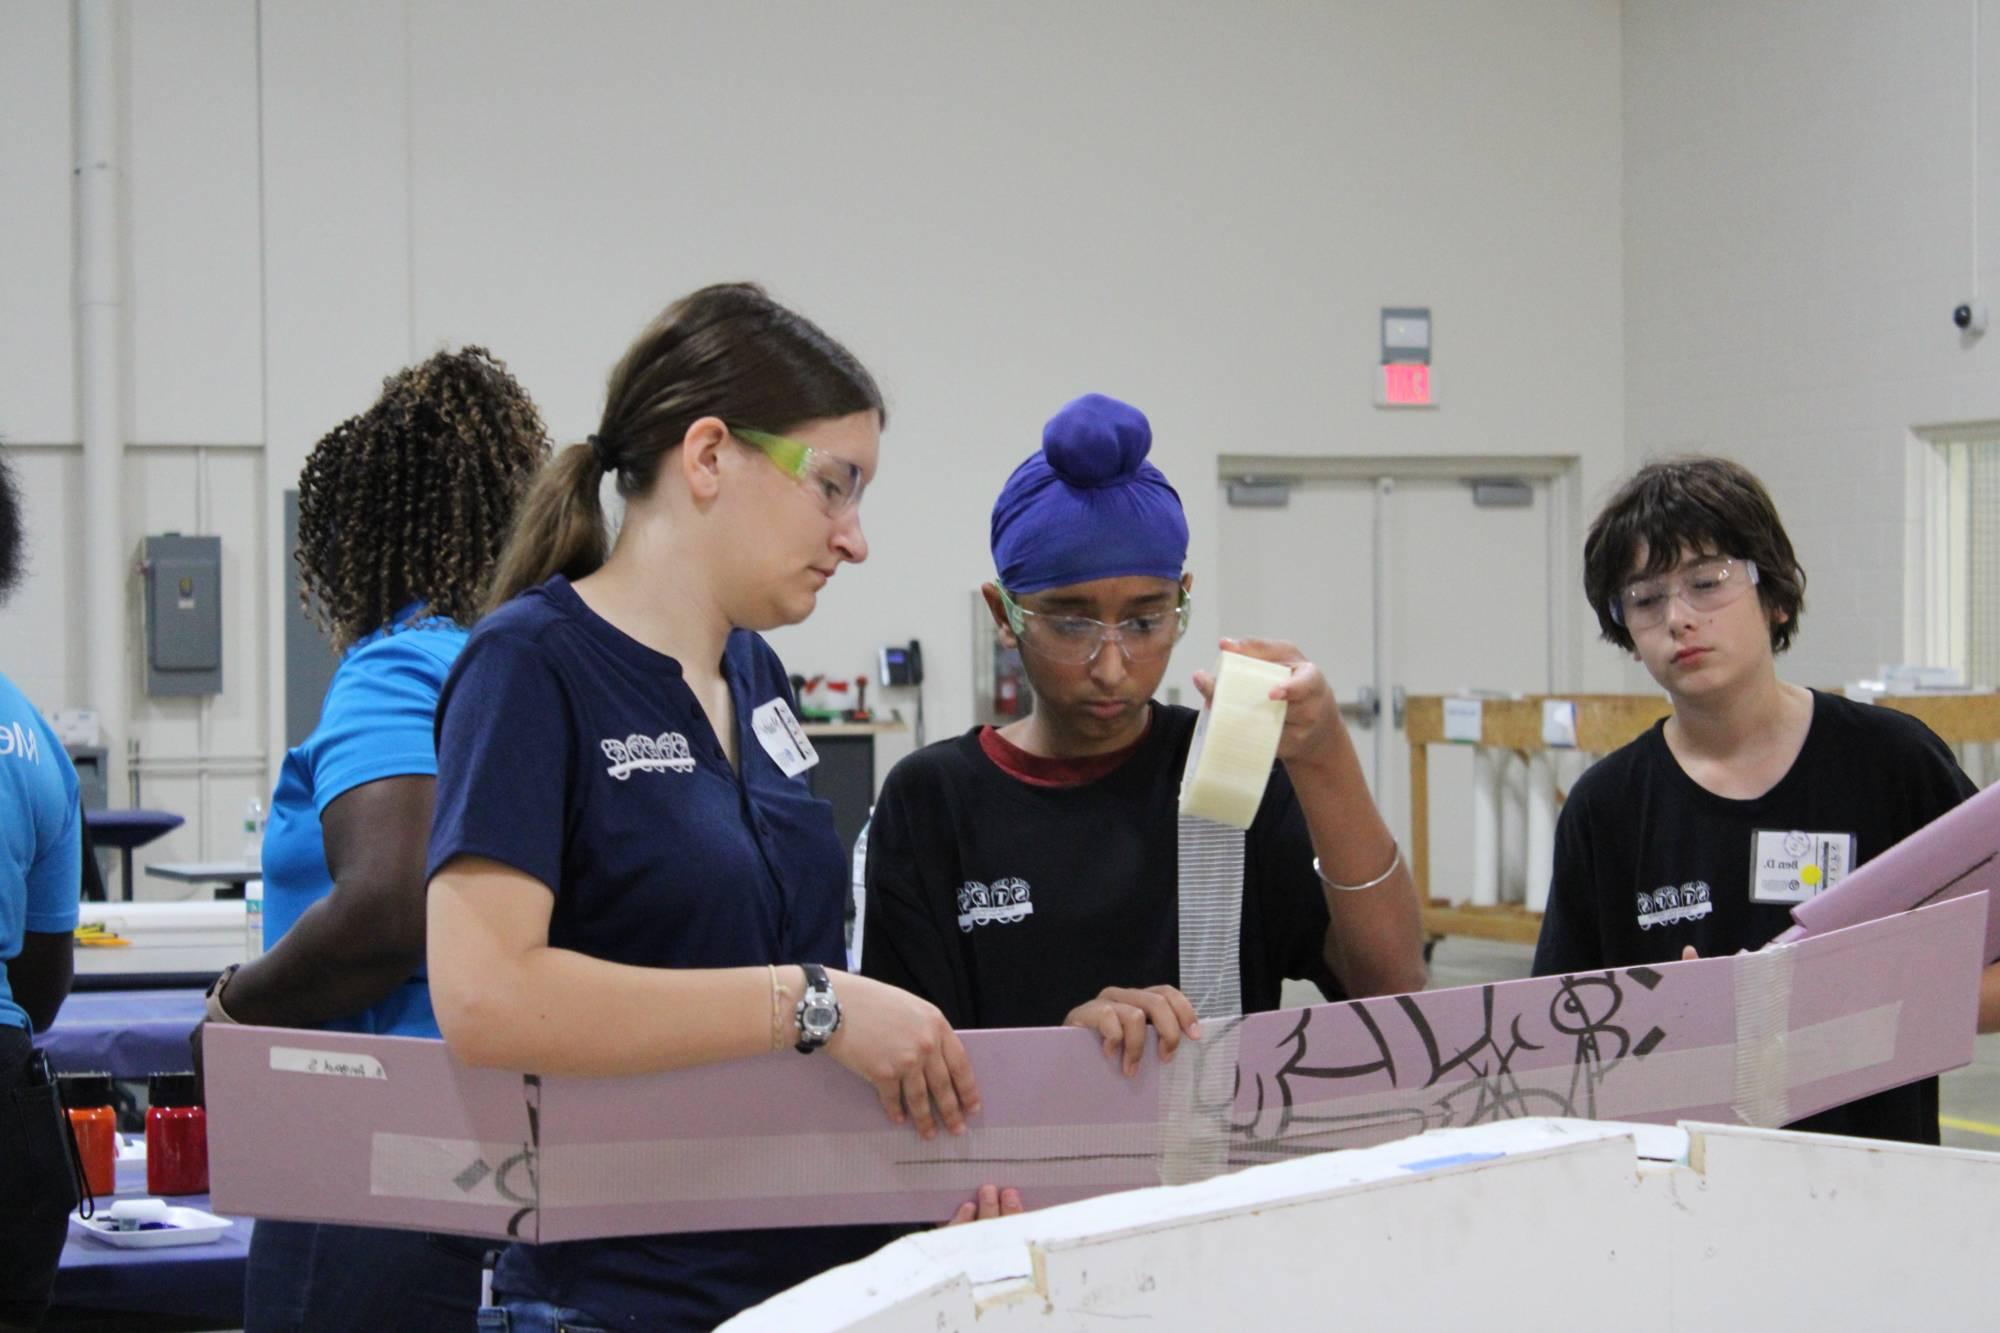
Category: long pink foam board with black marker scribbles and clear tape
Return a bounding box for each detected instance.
[206,897,1986,1241]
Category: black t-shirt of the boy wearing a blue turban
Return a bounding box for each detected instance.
[860,705,1338,1027]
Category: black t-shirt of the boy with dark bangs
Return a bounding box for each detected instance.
[1534,691,1976,1143]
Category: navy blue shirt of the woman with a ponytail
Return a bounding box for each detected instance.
[430,574,882,1329]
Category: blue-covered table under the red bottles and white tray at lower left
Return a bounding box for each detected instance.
[54,1195,254,1329]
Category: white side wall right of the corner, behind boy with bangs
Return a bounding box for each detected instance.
[1624,0,2000,685]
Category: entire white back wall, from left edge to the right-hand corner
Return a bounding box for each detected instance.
[0,0,1624,892]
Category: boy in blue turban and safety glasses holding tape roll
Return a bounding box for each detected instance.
[856,394,1424,1144]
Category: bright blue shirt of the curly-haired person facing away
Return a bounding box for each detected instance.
[264,604,466,1037]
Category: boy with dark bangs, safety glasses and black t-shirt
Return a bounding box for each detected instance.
[1534,458,2000,1143]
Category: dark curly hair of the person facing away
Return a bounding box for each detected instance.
[298,346,550,648]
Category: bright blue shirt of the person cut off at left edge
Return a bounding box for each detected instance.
[0,677,84,1027]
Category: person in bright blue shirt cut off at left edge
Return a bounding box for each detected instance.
[0,452,84,1329]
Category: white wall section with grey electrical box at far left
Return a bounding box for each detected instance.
[0,0,270,872]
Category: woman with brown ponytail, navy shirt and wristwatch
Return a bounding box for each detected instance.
[428,284,978,1333]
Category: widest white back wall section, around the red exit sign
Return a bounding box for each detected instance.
[386,4,1622,748]
